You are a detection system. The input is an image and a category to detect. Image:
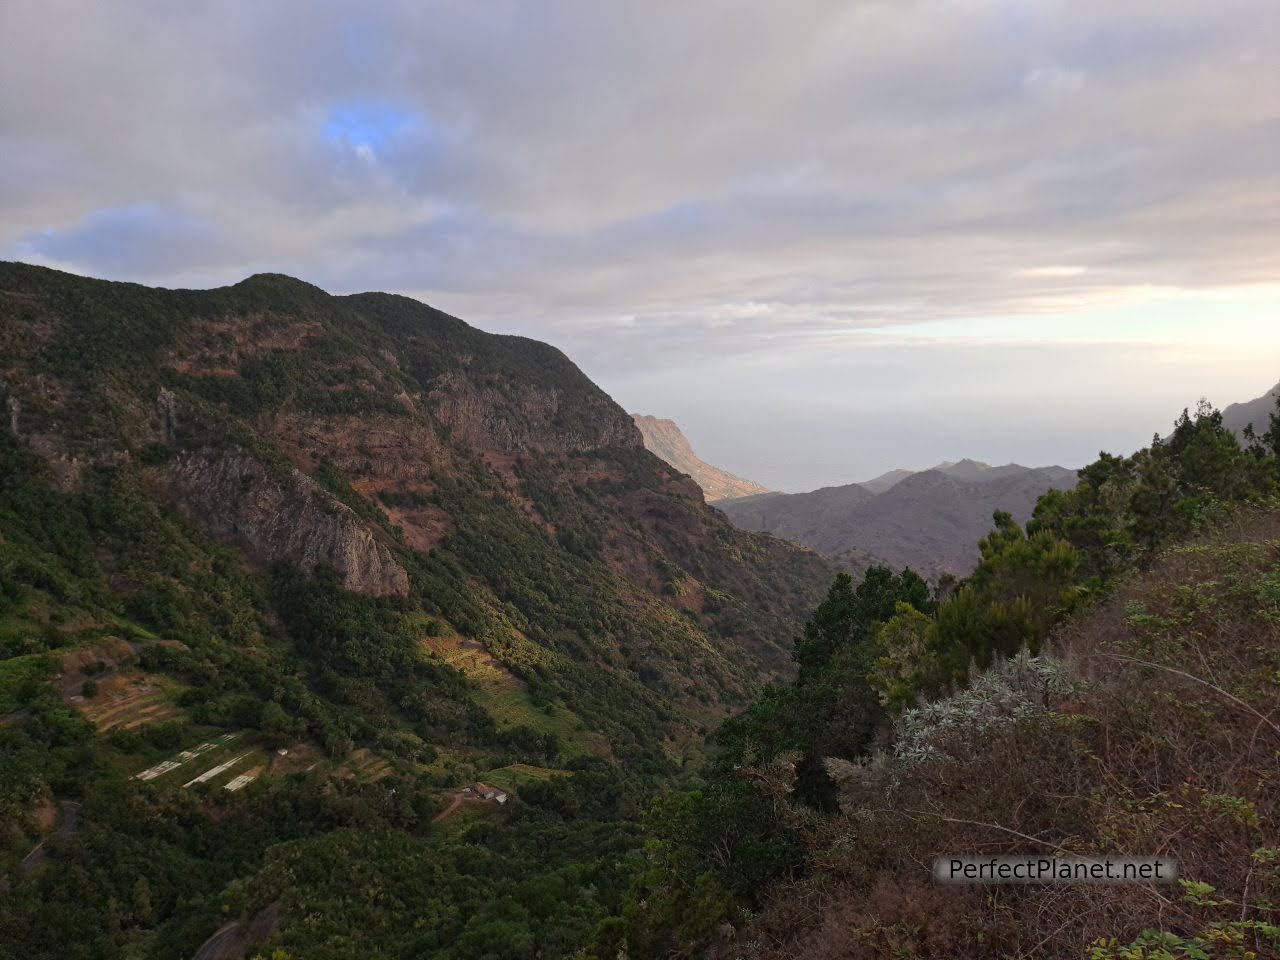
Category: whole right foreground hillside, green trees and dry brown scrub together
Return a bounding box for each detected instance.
[618,407,1280,960]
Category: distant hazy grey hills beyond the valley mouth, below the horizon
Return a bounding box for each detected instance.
[716,460,1076,579]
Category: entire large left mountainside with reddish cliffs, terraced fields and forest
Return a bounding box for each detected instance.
[0,264,829,960]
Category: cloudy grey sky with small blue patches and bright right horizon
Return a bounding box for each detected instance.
[0,0,1280,490]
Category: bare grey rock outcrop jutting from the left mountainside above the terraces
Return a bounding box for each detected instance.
[166,451,408,596]
